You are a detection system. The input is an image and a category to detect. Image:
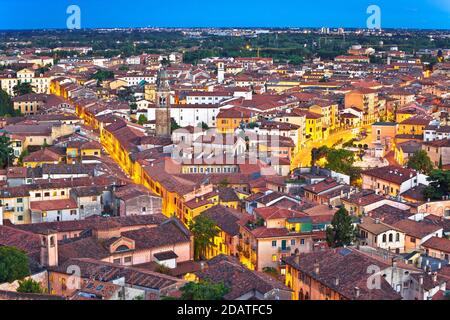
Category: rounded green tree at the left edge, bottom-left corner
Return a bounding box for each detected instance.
[0,246,30,283]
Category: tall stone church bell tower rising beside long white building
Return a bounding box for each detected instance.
[155,69,171,137]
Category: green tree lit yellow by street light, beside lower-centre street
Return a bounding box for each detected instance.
[189,215,219,260]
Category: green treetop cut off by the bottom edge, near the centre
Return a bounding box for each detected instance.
[180,281,230,300]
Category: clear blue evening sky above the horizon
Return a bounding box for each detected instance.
[0,0,450,29]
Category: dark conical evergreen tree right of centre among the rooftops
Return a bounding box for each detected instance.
[327,207,356,248]
